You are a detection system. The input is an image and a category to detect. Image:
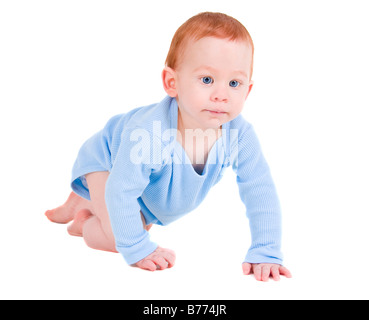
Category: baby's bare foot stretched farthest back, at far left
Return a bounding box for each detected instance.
[45,192,91,223]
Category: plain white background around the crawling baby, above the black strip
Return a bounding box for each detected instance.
[0,0,369,299]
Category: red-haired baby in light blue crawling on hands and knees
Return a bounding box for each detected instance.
[46,12,291,281]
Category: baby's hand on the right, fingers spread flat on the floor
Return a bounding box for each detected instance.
[242,262,292,281]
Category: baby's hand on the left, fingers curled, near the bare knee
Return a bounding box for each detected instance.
[133,247,176,271]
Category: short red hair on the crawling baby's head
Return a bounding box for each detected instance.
[165,12,254,79]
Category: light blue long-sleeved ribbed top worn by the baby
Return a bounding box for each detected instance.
[71,97,282,264]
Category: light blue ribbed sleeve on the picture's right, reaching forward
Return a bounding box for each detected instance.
[233,123,283,264]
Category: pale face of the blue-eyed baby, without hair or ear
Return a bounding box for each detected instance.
[175,37,253,130]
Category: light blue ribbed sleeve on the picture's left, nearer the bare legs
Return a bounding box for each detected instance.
[105,126,157,264]
